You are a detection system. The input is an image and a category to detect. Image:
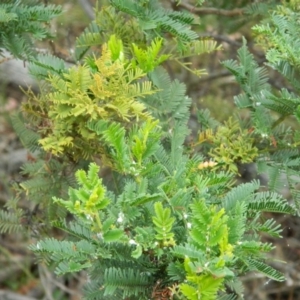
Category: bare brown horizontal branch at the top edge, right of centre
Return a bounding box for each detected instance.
[178,3,244,17]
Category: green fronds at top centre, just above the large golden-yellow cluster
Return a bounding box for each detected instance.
[75,1,221,76]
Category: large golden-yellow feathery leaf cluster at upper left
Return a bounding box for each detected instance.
[40,37,155,160]
